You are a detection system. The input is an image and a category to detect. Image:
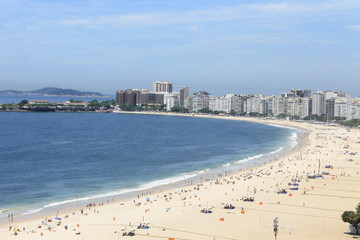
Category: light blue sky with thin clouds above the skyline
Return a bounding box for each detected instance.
[0,0,360,96]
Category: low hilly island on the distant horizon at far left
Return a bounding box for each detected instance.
[0,87,105,97]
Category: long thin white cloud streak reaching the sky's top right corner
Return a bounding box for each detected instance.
[61,0,360,27]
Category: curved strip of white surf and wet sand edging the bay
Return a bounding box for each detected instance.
[0,112,308,223]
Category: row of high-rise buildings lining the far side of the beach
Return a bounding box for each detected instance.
[116,81,360,120]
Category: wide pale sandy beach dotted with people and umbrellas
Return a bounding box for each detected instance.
[0,116,360,240]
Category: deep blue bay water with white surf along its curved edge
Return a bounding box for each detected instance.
[0,112,297,220]
